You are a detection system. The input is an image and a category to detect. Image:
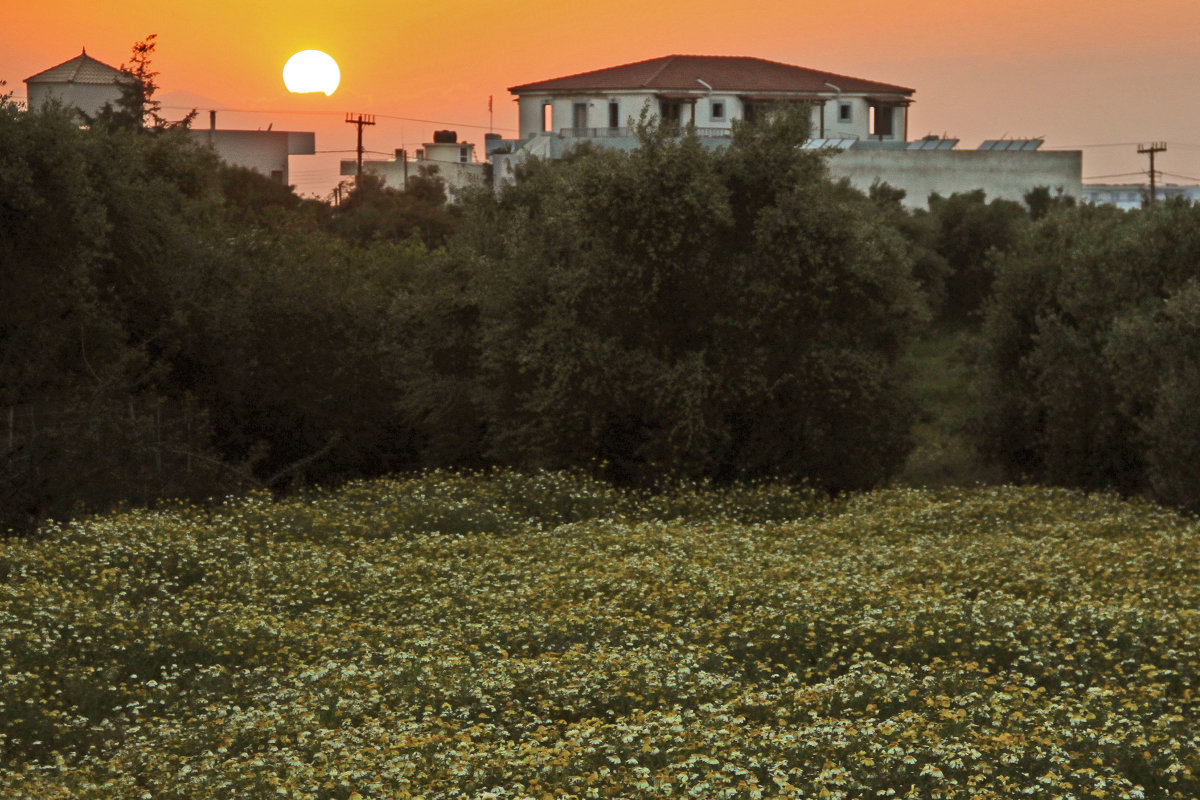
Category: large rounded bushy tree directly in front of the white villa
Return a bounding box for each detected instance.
[446,107,922,488]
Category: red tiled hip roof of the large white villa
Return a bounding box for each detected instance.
[509,55,914,95]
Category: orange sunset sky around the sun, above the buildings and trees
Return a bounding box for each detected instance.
[0,0,1200,197]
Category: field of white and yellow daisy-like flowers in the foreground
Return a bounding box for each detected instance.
[0,473,1200,800]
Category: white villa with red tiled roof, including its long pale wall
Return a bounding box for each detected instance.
[487,55,1082,207]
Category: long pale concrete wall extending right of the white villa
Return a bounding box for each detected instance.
[829,148,1084,207]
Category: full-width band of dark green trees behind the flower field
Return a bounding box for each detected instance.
[0,92,1200,529]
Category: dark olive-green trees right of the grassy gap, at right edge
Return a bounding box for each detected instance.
[978,203,1200,507]
